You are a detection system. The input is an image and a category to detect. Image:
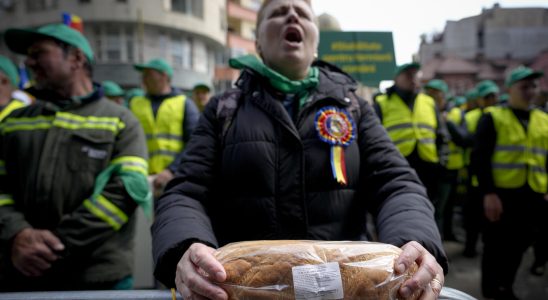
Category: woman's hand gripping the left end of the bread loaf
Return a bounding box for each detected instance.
[175,243,228,300]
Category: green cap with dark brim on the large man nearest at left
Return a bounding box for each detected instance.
[4,24,93,63]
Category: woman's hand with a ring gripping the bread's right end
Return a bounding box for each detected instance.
[394,241,445,300]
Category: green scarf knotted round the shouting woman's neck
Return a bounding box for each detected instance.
[228,55,319,108]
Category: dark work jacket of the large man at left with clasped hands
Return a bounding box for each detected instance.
[0,85,148,290]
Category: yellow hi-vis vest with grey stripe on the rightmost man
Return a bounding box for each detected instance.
[491,107,548,194]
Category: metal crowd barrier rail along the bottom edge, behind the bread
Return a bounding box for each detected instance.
[0,287,477,300]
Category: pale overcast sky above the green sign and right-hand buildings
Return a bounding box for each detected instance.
[312,0,548,64]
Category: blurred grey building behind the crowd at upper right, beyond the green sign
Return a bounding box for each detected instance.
[419,4,548,94]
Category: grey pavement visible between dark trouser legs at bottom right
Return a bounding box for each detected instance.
[443,214,548,300]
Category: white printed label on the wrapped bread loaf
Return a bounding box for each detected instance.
[292,262,344,300]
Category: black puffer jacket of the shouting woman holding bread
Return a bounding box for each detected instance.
[152,63,447,286]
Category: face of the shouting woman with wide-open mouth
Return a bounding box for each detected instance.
[256,0,319,80]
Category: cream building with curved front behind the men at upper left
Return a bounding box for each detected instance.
[0,0,228,90]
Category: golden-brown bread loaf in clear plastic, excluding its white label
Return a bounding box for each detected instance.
[215,240,417,300]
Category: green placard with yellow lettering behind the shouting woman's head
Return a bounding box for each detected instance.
[319,31,396,86]
